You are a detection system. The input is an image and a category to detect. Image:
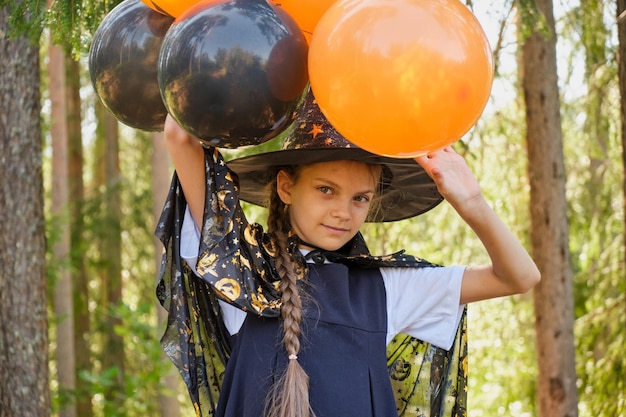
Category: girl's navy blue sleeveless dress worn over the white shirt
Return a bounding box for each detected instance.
[216,264,398,417]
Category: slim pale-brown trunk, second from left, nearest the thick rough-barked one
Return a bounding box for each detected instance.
[48,35,76,417]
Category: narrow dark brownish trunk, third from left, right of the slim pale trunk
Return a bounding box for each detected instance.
[65,56,93,417]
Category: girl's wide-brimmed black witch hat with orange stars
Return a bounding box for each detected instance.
[222,90,443,222]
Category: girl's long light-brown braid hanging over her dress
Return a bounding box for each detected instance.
[267,171,314,417]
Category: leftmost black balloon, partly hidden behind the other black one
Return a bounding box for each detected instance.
[89,0,174,131]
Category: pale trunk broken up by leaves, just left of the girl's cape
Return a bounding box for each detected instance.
[151,133,180,417]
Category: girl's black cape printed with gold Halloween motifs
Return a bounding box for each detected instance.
[155,148,467,417]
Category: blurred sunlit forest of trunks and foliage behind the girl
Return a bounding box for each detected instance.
[0,0,626,417]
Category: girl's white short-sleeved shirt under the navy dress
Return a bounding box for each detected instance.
[180,208,465,350]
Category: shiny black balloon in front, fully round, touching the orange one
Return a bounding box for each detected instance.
[158,0,308,148]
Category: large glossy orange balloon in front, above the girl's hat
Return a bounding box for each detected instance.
[309,0,493,158]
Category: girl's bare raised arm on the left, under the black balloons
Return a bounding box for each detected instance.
[164,114,205,229]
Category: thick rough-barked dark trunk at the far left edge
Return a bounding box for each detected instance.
[0,6,50,417]
